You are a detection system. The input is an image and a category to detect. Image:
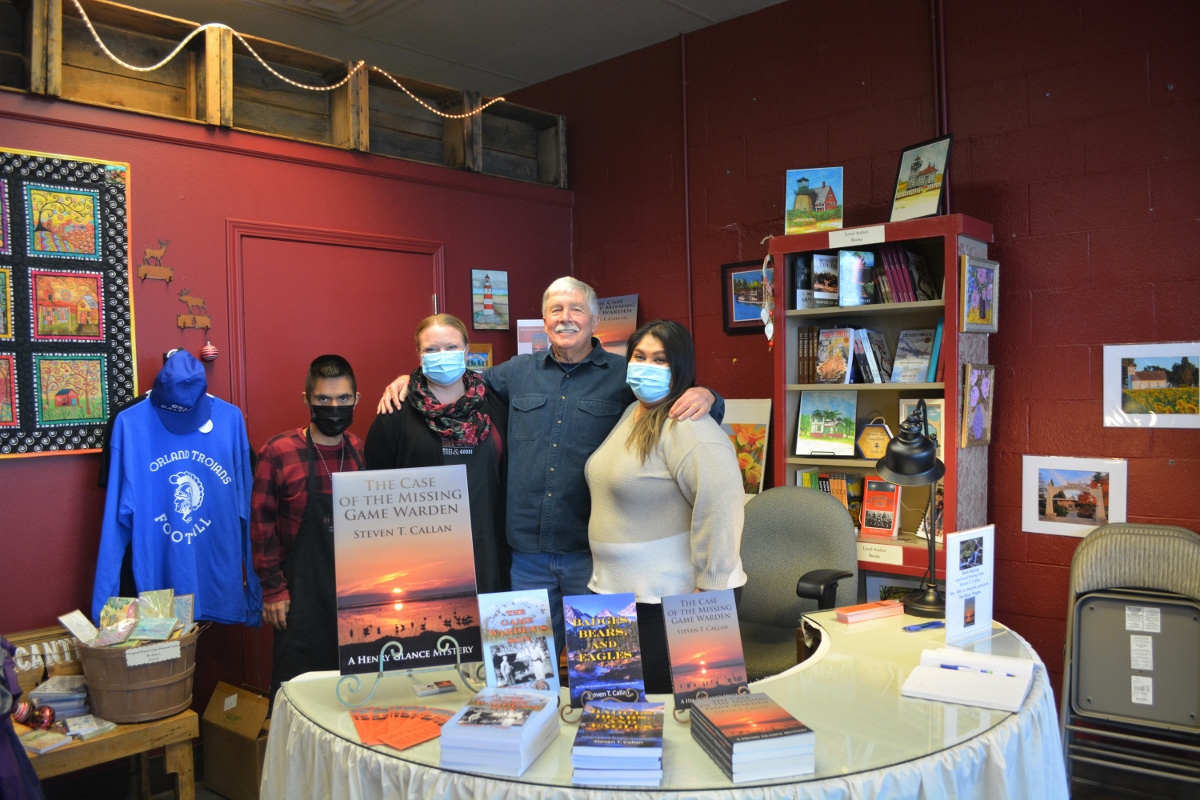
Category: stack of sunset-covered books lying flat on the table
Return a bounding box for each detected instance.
[691,694,816,783]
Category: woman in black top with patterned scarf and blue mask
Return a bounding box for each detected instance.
[365,314,511,591]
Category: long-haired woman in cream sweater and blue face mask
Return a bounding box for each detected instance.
[586,319,746,693]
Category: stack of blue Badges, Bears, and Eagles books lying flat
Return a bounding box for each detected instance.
[571,700,664,786]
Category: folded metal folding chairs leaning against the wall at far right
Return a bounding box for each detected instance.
[1061,523,1200,792]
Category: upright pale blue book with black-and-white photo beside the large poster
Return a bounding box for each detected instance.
[479,589,558,692]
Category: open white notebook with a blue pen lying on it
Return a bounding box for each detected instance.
[900,648,1034,711]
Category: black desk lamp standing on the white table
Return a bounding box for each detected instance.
[875,401,946,618]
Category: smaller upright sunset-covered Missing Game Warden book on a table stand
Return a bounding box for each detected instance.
[662,589,750,709]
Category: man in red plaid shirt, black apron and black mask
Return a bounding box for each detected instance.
[250,355,362,700]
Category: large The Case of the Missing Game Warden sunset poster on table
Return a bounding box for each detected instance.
[332,464,482,675]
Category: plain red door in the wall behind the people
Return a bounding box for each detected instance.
[232,229,442,691]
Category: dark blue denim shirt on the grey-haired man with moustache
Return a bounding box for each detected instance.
[484,338,725,553]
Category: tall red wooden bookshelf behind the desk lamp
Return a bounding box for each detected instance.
[769,213,992,577]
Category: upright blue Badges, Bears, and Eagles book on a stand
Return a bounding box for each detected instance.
[563,593,646,709]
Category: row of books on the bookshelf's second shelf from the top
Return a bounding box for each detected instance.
[797,320,943,384]
